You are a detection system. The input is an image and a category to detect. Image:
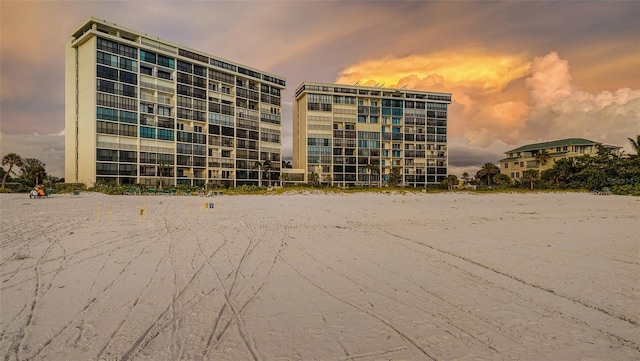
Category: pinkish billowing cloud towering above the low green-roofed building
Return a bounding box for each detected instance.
[520,53,640,147]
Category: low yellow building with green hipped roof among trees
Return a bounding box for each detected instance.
[500,138,621,179]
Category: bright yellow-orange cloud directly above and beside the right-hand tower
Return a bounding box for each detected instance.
[337,51,529,147]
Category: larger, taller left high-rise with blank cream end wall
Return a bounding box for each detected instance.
[65,18,285,186]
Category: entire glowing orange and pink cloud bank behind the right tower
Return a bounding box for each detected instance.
[336,51,640,150]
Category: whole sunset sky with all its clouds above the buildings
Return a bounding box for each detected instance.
[0,0,640,177]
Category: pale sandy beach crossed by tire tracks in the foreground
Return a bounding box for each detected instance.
[0,193,640,360]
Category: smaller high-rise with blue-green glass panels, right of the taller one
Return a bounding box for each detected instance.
[293,83,451,187]
